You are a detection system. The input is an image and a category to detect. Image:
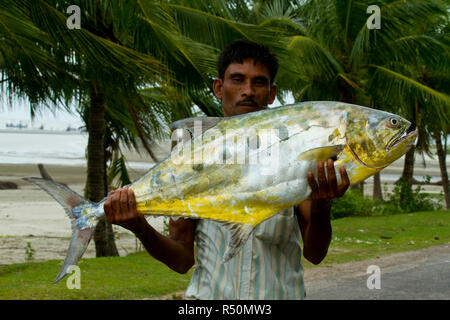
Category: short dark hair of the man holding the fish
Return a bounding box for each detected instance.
[217,39,278,83]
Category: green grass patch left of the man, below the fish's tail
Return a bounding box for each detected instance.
[0,252,192,300]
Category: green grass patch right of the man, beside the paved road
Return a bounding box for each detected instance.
[303,211,450,268]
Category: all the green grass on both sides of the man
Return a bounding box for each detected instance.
[0,211,450,300]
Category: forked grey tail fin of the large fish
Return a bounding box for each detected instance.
[23,178,103,283]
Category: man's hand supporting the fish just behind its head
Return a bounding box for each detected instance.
[308,159,350,200]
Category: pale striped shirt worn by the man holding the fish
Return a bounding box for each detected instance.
[186,208,305,300]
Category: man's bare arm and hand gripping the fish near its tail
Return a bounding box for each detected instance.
[104,187,195,273]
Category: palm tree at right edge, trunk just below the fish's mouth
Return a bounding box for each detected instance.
[364,1,450,204]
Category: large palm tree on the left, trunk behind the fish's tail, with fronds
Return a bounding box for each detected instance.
[0,0,224,256]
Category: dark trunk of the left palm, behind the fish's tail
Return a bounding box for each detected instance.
[87,85,119,257]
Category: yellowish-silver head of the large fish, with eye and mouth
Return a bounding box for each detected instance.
[345,108,417,169]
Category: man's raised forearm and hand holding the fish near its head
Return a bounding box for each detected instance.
[297,159,350,264]
